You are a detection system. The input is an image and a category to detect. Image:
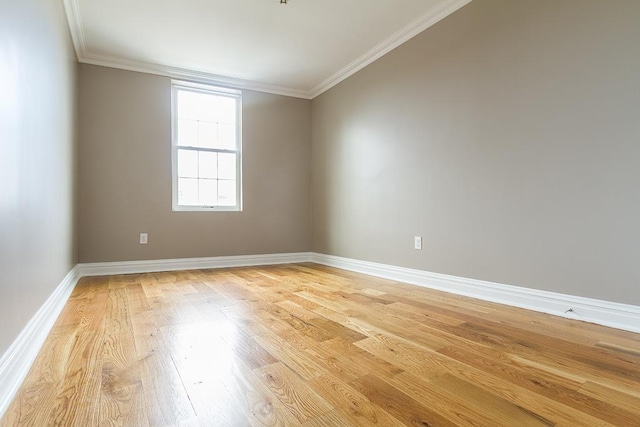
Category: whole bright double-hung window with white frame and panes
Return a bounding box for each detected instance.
[171,81,242,211]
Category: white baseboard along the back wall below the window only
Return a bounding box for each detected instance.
[78,252,312,277]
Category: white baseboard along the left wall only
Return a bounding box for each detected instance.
[0,266,80,418]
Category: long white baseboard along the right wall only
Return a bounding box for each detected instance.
[311,253,640,333]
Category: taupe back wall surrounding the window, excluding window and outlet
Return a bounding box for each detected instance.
[78,64,311,262]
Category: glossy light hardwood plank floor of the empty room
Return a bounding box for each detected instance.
[0,264,640,427]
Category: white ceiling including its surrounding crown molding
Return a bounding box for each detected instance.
[64,0,471,99]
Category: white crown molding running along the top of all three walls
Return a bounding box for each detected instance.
[63,0,472,99]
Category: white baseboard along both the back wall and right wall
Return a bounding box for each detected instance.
[77,252,640,333]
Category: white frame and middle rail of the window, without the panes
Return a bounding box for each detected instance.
[171,80,242,212]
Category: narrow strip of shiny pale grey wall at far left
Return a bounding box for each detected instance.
[0,0,75,357]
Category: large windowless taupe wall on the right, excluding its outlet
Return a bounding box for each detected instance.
[312,0,640,305]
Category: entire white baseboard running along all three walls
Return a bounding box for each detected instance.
[0,252,640,417]
